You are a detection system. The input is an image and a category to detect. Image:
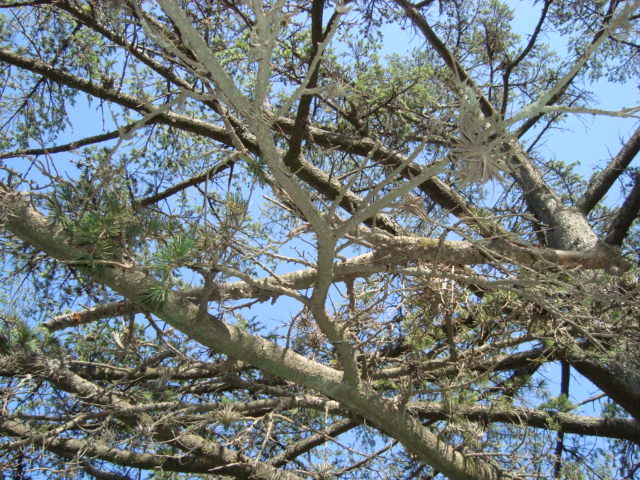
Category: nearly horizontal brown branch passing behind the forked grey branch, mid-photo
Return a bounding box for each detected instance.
[43,234,628,331]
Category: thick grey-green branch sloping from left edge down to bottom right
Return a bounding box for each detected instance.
[0,186,509,480]
